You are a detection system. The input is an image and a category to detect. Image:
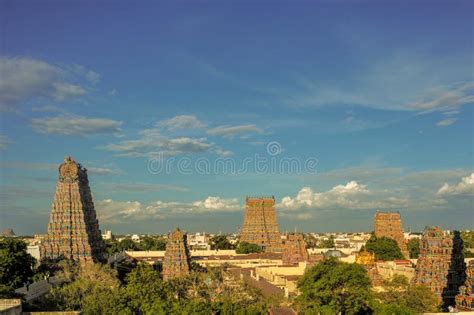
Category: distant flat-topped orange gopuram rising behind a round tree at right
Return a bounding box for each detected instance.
[374,211,410,258]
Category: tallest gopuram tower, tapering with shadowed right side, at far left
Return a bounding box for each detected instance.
[40,156,105,261]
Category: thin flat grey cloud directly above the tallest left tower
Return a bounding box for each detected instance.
[31,115,122,136]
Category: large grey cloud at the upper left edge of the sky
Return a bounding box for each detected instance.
[0,57,95,110]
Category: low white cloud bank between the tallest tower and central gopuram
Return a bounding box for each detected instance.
[96,196,241,223]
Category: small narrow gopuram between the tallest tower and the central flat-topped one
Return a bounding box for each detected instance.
[163,228,190,280]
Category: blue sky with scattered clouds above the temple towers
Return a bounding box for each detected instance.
[0,0,474,234]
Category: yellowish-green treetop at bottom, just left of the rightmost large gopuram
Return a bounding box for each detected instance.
[375,275,438,314]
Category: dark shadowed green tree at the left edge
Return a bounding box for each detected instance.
[0,237,36,289]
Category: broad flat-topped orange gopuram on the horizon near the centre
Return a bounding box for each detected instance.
[240,196,282,252]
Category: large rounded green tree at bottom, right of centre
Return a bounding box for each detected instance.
[295,259,372,314]
